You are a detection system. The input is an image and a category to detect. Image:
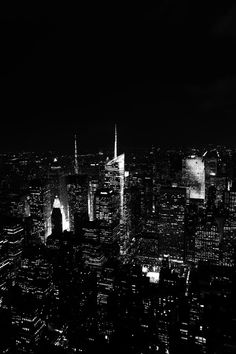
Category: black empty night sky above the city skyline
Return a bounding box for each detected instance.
[0,0,236,151]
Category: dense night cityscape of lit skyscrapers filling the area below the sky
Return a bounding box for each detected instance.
[0,127,236,354]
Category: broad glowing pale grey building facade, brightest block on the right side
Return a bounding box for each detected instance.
[182,156,205,201]
